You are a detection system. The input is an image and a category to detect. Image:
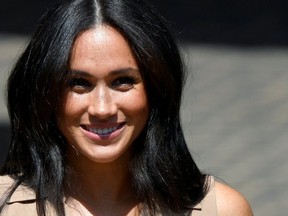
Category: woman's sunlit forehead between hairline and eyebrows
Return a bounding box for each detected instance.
[70,25,137,73]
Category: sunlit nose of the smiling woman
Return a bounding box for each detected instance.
[88,86,117,120]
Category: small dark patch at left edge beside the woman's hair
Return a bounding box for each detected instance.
[0,123,11,164]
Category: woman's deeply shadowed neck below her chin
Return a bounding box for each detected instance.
[66,149,136,208]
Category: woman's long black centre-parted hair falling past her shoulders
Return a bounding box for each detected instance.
[0,0,206,215]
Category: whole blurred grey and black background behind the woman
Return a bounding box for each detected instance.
[0,0,288,216]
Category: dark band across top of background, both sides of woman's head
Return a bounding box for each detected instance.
[0,0,288,46]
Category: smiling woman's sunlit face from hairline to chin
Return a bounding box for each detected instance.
[58,26,148,163]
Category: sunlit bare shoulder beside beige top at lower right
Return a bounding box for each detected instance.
[215,182,253,216]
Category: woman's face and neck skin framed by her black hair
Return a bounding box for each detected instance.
[58,25,149,216]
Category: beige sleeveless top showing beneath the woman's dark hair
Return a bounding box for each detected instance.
[0,176,218,216]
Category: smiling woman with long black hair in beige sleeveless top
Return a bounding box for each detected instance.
[0,0,252,216]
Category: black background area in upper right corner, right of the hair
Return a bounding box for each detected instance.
[150,0,288,46]
